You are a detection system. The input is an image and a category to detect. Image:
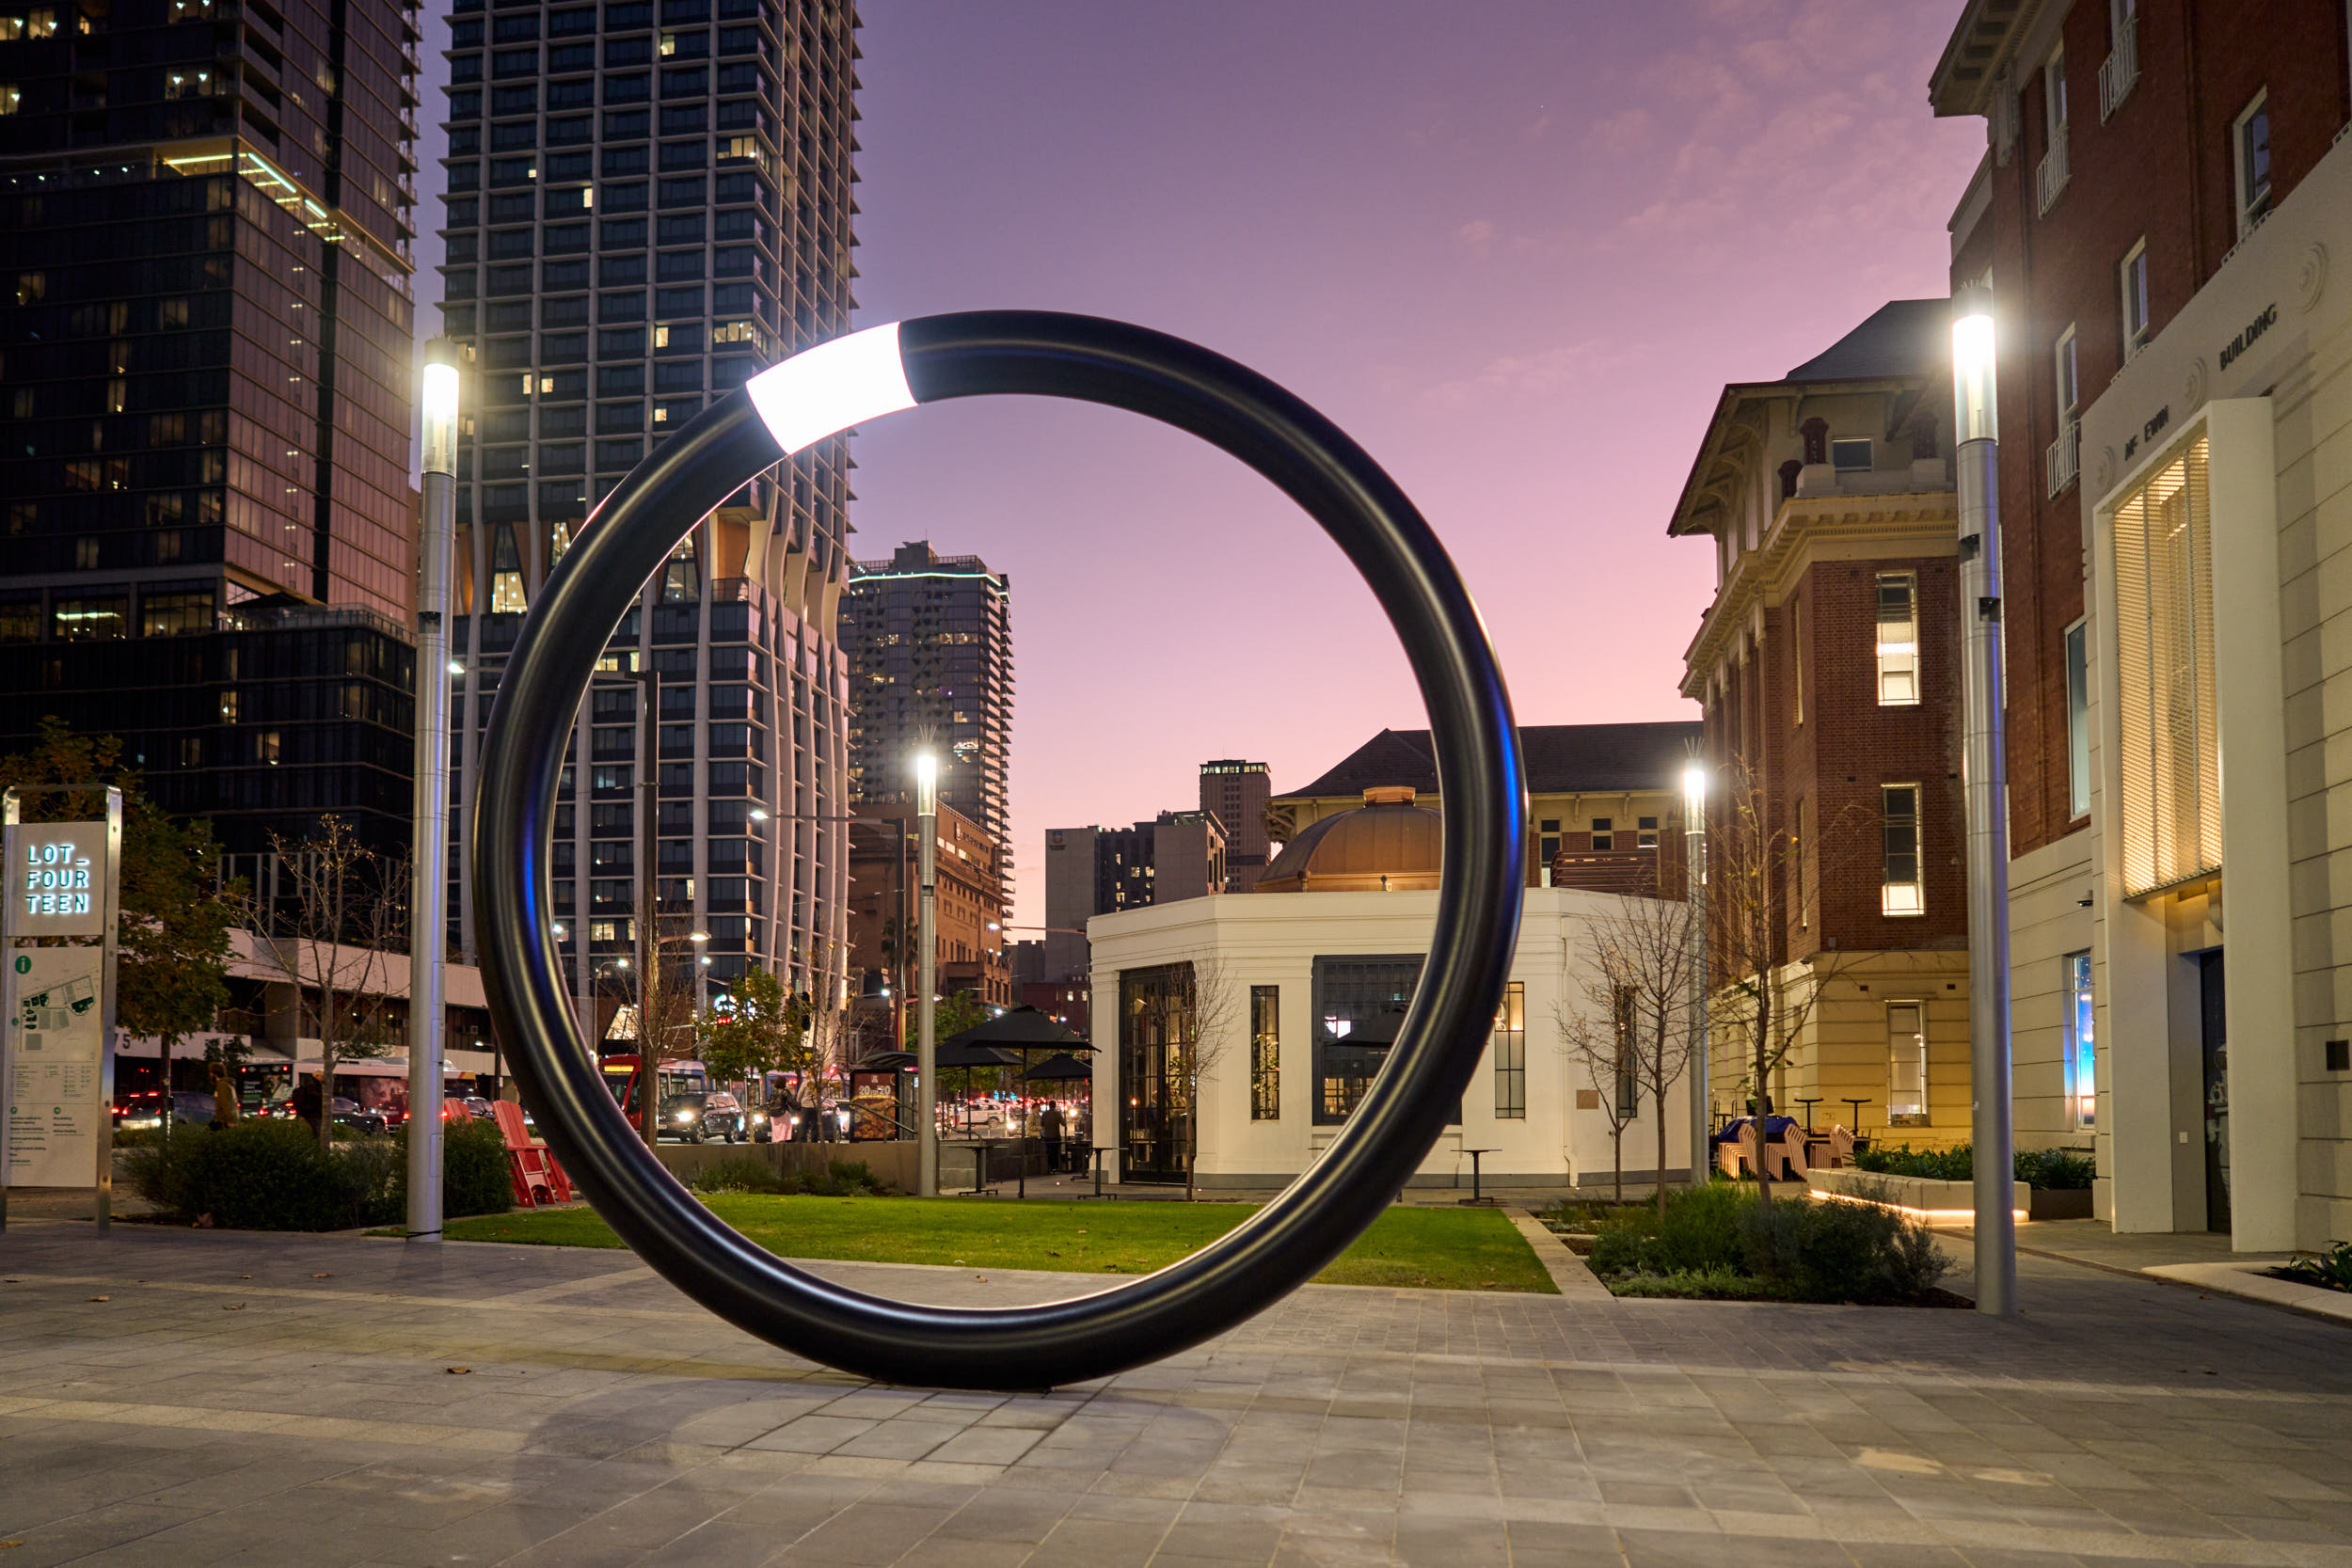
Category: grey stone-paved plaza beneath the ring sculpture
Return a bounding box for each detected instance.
[0,1223,2352,1568]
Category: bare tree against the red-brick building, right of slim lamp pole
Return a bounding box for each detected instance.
[1708,762,1867,1204]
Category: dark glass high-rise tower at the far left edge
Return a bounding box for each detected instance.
[0,0,417,851]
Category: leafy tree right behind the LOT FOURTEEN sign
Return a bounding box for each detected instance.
[0,717,245,1079]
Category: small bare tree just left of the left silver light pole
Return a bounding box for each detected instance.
[257,814,409,1145]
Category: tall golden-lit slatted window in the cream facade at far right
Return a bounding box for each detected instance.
[2112,435,2220,895]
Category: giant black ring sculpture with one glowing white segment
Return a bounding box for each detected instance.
[473,310,1527,1389]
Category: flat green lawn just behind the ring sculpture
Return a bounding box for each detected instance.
[433,1192,1555,1293]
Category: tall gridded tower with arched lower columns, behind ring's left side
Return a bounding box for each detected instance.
[442,0,859,1016]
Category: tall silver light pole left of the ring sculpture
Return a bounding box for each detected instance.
[409,339,459,1242]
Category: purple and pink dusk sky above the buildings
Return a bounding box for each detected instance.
[851,0,1983,924]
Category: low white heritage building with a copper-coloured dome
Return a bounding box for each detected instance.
[1087,787,1692,1192]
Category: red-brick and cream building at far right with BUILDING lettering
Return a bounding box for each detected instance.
[1931,0,2352,1251]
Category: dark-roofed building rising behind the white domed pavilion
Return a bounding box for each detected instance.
[1265,721,1701,898]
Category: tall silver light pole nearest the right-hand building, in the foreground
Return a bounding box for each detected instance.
[1952,289,2018,1317]
